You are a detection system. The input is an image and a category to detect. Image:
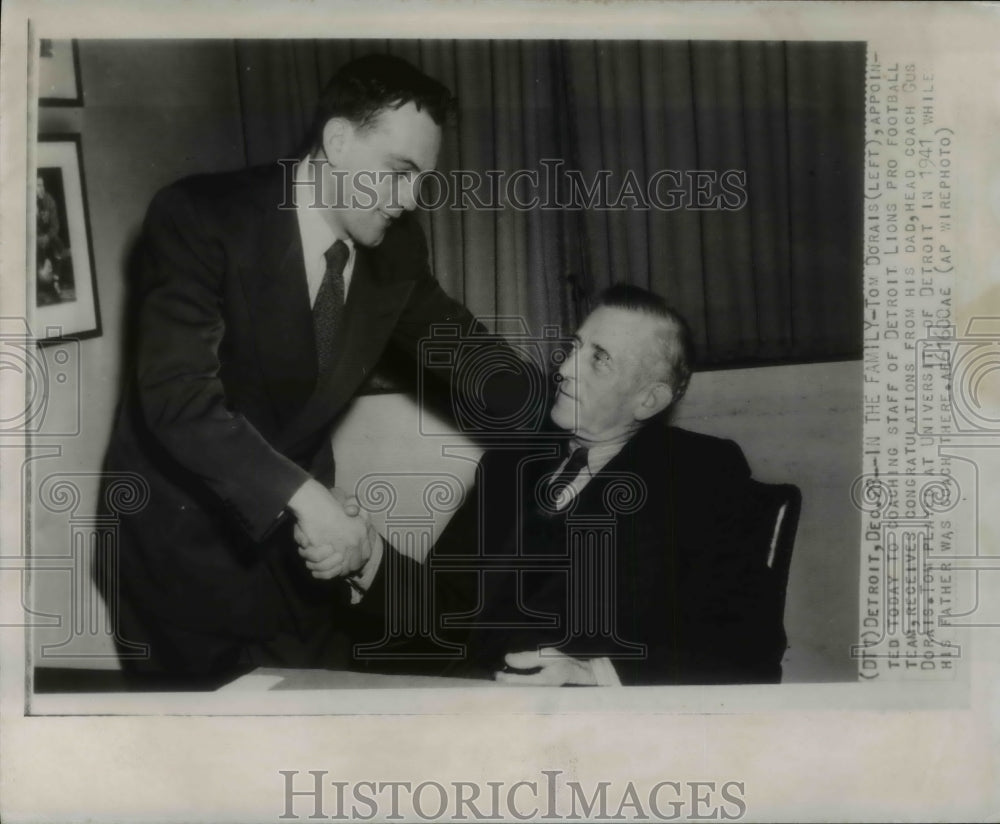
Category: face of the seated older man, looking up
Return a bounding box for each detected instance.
[550,306,662,443]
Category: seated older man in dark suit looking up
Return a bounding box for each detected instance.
[305,285,785,685]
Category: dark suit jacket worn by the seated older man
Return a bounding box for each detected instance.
[358,423,785,684]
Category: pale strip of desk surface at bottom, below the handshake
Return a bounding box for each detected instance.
[218,667,496,692]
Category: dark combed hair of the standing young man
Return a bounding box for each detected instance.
[306,54,456,151]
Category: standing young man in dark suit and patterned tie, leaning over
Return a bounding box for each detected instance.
[98,55,524,677]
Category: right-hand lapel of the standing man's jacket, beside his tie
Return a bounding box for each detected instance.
[278,248,413,448]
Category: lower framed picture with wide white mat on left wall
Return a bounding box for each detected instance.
[28,135,101,343]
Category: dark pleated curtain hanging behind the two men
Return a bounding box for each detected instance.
[230,40,865,367]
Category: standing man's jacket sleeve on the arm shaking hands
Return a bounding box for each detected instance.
[136,187,309,541]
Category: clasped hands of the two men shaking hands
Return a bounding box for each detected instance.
[288,480,379,580]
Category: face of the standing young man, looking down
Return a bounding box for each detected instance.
[323,103,441,246]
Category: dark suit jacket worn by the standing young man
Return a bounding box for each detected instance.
[106,166,508,652]
